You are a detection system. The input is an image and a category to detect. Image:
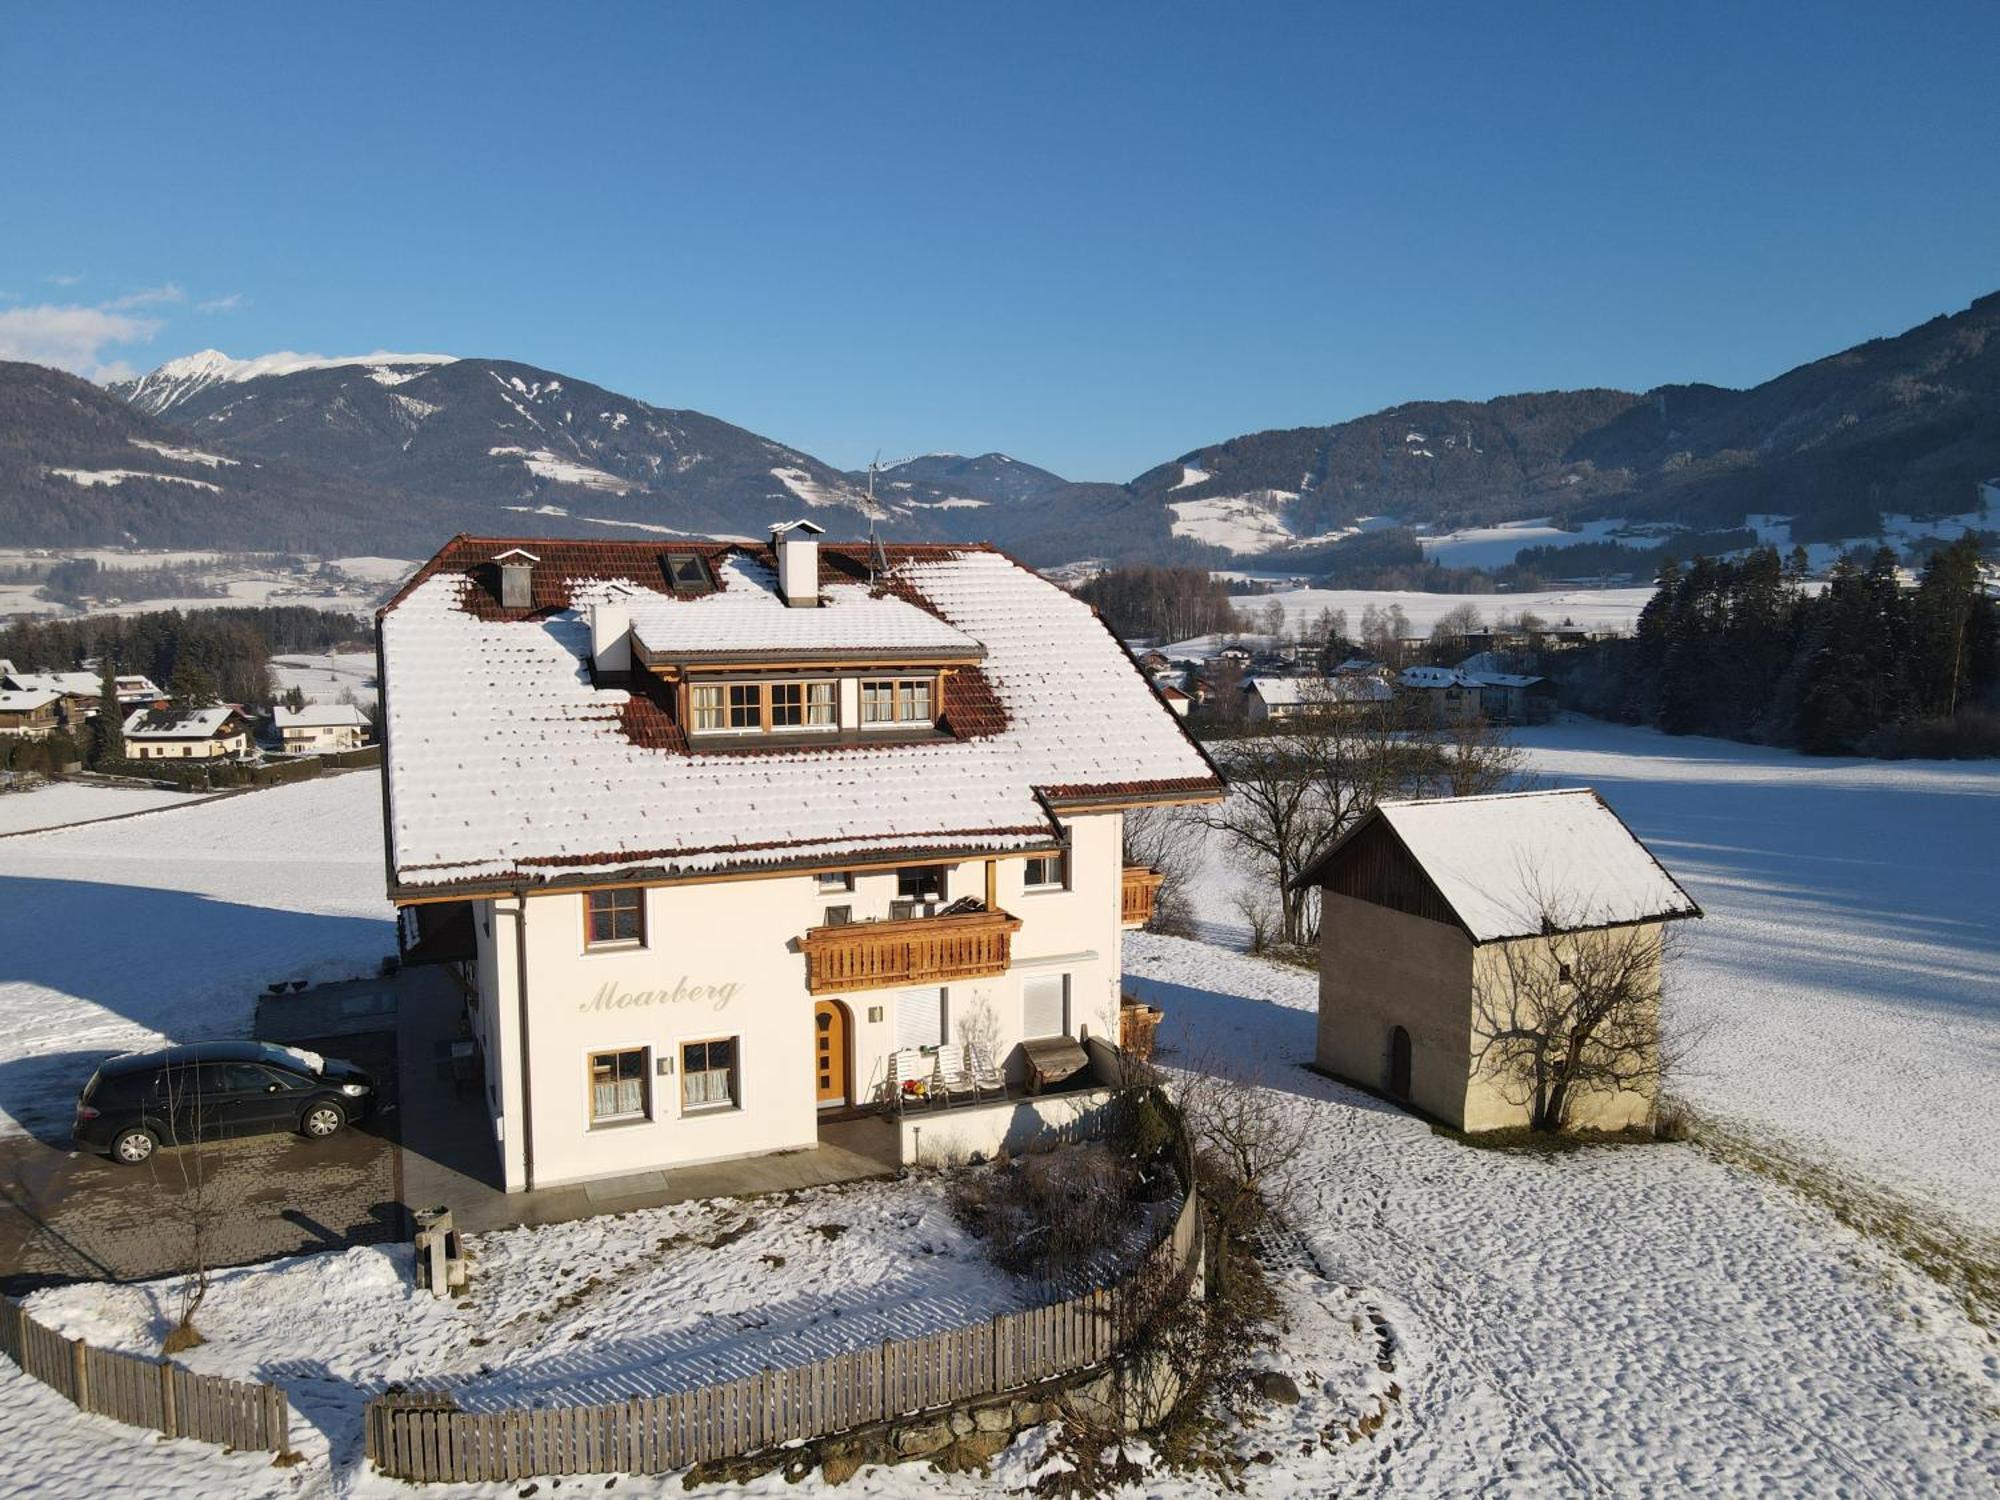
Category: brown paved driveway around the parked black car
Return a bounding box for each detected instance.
[0,1032,406,1292]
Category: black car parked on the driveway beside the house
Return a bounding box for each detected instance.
[72,1042,376,1166]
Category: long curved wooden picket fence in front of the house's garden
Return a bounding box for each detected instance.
[364,1190,1202,1482]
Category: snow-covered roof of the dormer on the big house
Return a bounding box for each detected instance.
[626,554,982,662]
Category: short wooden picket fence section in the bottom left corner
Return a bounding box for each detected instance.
[0,1298,292,1454]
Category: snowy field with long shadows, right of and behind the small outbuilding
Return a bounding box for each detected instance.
[1516,720,2000,1232]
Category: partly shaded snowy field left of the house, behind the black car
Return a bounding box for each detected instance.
[0,772,396,1134]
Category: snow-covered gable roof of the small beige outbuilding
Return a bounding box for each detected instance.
[1302,788,1702,942]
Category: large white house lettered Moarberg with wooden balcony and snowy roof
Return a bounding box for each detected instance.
[380,522,1222,1190]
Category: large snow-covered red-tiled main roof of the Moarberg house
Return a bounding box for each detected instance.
[380,538,1220,890]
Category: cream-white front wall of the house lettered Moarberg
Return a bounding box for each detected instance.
[464,814,1124,1188]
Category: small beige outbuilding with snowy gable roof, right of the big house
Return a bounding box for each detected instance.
[1298,788,1700,1130]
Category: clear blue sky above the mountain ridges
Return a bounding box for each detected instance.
[0,0,2000,480]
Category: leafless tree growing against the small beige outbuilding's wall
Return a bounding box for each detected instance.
[1472,882,1702,1132]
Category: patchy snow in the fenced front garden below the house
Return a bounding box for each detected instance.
[28,1176,1046,1460]
